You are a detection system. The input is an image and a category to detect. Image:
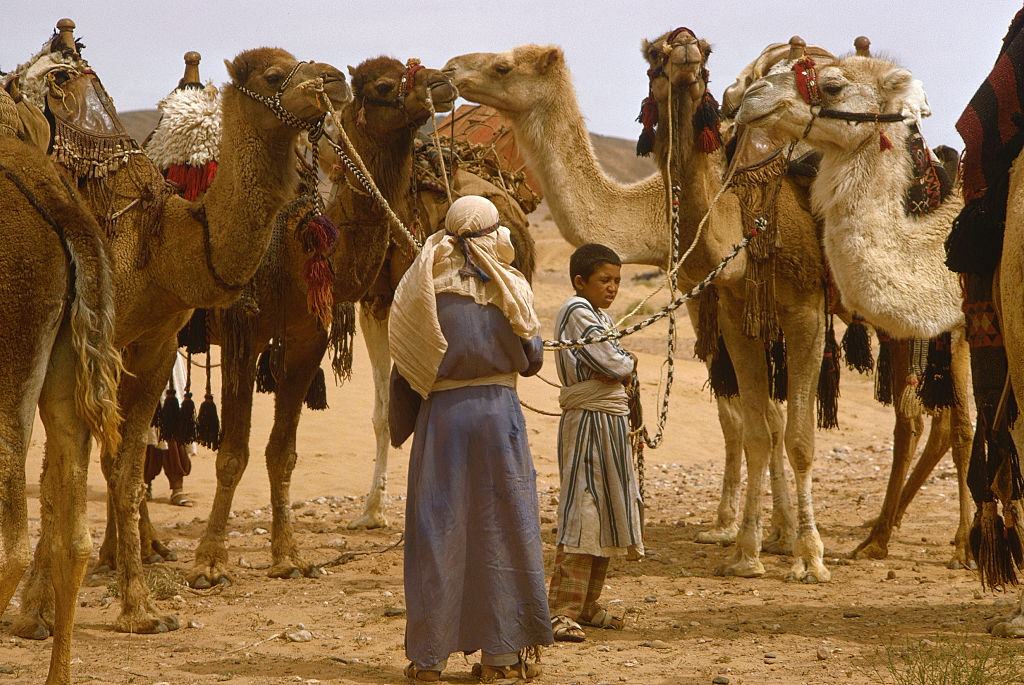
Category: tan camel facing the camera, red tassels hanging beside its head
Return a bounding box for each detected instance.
[643,31,830,582]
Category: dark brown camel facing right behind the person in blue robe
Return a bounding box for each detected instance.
[188,57,532,588]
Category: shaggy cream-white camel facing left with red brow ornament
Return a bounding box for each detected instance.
[737,56,973,565]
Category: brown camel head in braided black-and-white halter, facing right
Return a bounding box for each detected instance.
[224,47,352,130]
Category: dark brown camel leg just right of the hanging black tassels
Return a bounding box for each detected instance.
[186,321,256,590]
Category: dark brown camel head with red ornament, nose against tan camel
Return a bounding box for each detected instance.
[348,56,459,132]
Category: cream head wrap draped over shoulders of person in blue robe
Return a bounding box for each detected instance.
[388,196,541,397]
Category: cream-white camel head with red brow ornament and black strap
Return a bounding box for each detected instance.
[736,55,927,155]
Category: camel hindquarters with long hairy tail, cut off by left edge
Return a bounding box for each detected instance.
[0,89,121,683]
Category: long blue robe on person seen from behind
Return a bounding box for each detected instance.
[389,294,553,668]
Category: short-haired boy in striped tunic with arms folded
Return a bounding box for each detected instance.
[548,244,643,642]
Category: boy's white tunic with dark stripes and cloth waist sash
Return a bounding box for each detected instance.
[555,297,643,557]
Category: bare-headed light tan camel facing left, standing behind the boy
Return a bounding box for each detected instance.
[444,45,795,544]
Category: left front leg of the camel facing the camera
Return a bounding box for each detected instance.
[716,289,772,577]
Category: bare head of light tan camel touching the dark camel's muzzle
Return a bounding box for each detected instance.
[443,45,568,114]
